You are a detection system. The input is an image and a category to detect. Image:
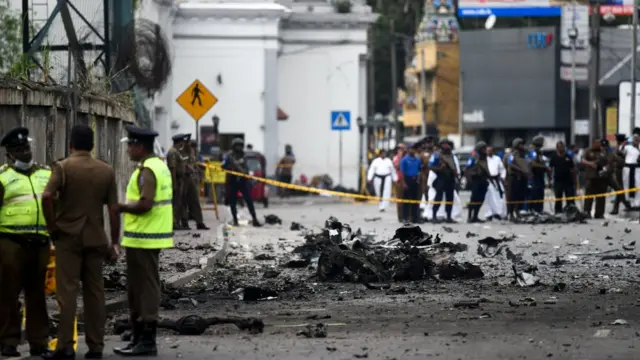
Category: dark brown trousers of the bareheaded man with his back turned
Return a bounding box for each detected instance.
[55,236,108,352]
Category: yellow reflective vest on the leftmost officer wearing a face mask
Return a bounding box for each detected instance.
[0,165,51,236]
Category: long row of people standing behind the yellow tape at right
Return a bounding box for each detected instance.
[367,129,640,223]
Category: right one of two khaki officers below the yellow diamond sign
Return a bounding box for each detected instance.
[182,134,209,230]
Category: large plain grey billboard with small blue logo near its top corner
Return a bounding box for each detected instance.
[460,27,559,129]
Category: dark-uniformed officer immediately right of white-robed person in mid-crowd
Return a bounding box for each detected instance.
[507,138,532,220]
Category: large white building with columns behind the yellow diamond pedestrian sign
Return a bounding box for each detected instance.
[144,0,376,188]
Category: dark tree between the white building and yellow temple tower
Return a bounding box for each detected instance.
[367,0,424,114]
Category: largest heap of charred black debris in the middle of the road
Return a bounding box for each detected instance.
[293,217,484,288]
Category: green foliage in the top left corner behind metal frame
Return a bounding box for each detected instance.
[0,0,22,73]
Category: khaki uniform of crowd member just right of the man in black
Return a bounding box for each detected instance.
[583,148,611,219]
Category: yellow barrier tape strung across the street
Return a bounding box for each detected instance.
[201,164,640,205]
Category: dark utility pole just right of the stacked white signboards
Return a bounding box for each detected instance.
[589,0,602,141]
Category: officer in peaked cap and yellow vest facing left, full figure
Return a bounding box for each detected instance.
[114,126,173,356]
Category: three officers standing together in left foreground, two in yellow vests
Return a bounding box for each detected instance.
[0,125,174,360]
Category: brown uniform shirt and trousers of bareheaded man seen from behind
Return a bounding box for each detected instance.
[46,151,118,352]
